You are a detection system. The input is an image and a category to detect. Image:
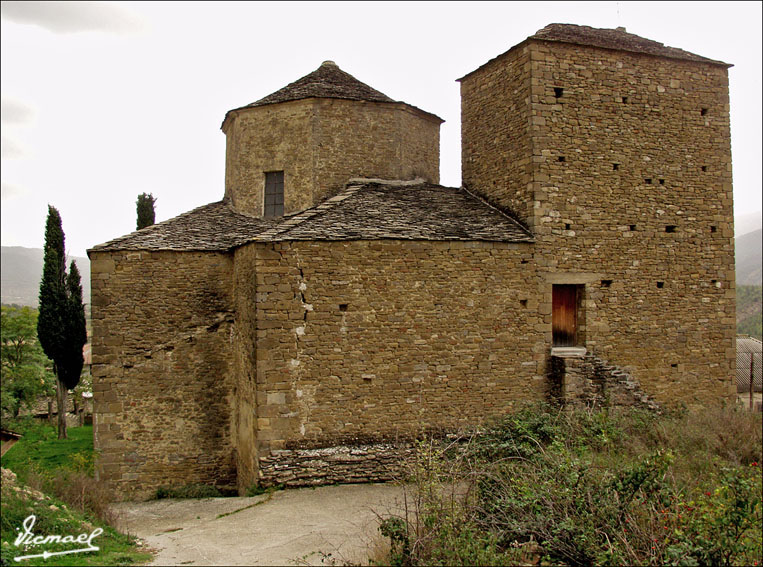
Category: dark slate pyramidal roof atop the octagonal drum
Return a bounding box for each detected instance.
[244,61,395,108]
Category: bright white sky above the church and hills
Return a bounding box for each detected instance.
[0,2,762,256]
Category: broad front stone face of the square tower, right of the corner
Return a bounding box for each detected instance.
[530,42,735,406]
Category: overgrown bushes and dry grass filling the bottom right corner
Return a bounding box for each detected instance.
[382,405,763,565]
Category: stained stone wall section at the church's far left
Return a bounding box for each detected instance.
[90,251,236,499]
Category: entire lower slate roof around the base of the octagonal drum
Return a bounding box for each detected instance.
[90,180,534,252]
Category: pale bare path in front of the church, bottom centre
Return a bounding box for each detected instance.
[115,484,403,565]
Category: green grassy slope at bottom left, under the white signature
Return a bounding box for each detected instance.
[0,424,151,565]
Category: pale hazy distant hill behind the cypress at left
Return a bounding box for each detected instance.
[0,246,90,307]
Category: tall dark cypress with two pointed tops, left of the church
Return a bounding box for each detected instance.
[37,206,87,439]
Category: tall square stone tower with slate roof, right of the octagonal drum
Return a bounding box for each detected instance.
[460,24,735,405]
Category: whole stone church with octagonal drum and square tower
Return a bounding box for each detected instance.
[89,24,735,498]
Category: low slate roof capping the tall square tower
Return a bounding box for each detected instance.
[458,24,732,81]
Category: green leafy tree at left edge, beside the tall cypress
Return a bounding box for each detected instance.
[0,305,53,419]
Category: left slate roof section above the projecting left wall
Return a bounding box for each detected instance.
[88,201,276,252]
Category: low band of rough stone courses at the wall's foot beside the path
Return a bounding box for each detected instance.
[260,443,415,486]
